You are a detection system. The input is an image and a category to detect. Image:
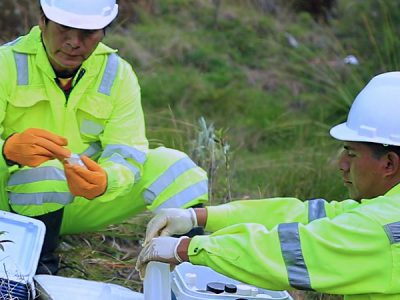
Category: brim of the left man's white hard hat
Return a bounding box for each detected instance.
[41,0,118,30]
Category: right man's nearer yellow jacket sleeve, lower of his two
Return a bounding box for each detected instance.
[188,200,394,294]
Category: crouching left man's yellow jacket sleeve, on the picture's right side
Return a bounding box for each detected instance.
[98,59,148,201]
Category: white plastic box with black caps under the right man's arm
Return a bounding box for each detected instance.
[171,262,293,300]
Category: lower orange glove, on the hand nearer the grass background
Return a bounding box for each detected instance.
[64,156,107,200]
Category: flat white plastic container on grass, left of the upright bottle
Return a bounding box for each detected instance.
[34,275,144,300]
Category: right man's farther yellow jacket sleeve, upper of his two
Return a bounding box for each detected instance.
[205,198,359,232]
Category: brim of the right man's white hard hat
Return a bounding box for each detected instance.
[329,123,400,146]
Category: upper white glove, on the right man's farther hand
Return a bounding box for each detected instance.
[144,208,198,245]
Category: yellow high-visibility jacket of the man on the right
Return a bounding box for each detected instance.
[189,184,400,300]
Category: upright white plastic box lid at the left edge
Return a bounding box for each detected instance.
[0,211,46,300]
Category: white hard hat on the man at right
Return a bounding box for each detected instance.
[330,72,400,146]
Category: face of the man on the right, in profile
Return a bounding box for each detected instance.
[339,142,387,200]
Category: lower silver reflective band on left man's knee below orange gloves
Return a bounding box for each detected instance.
[8,192,74,205]
